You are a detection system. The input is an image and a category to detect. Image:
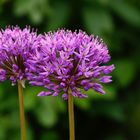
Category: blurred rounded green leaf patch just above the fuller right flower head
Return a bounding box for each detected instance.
[83,8,113,35]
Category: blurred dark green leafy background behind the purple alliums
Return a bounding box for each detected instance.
[0,0,140,140]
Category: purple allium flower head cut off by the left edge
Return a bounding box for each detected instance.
[0,26,40,86]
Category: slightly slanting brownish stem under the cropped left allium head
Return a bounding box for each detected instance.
[18,81,26,140]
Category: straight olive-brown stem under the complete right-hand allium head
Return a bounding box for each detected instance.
[68,90,75,140]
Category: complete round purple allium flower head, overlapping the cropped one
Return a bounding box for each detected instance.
[26,30,114,99]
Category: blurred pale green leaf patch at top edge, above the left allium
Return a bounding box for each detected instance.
[14,0,51,24]
